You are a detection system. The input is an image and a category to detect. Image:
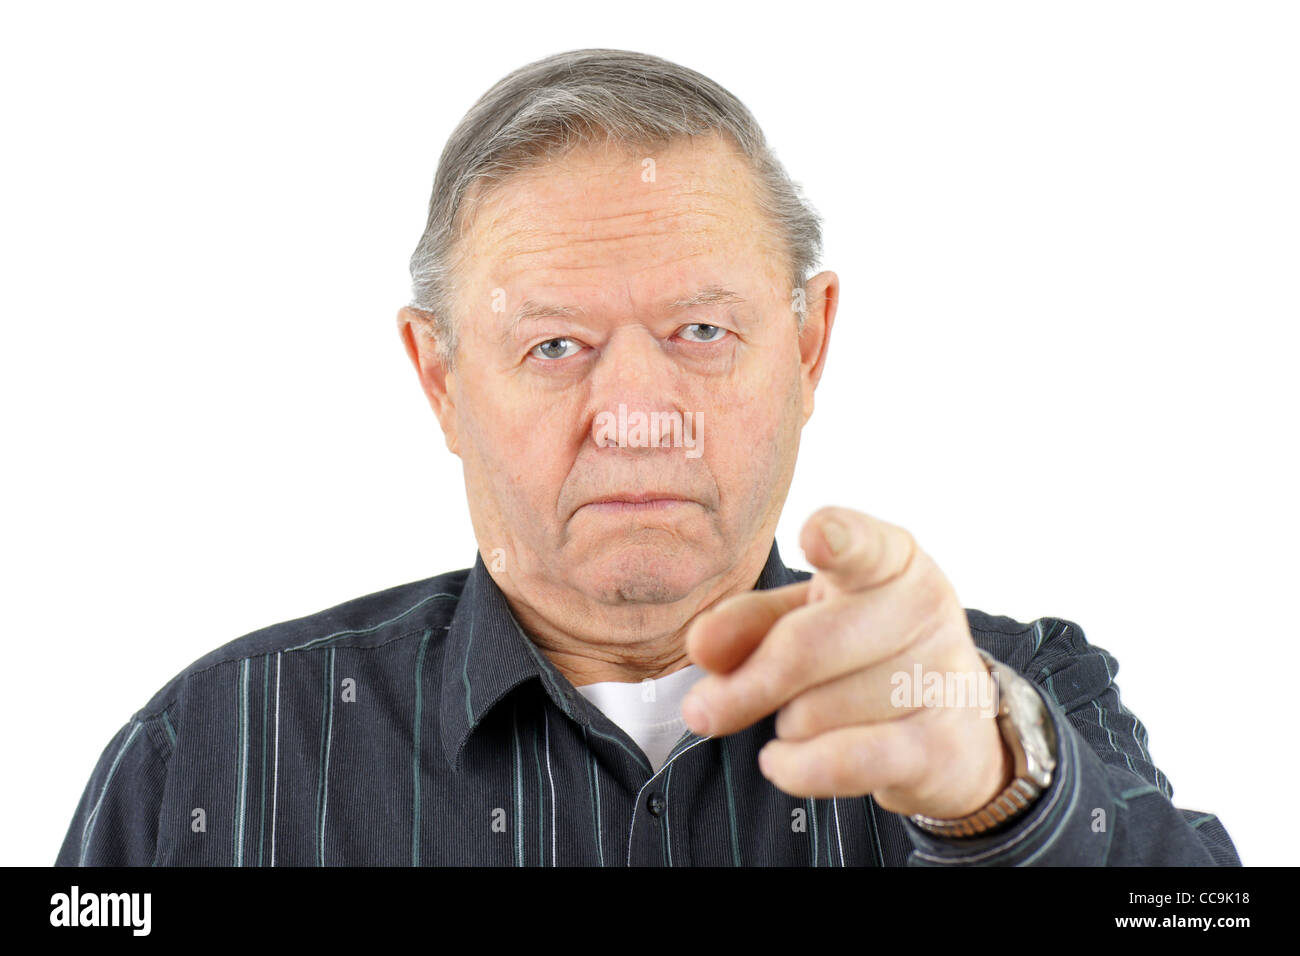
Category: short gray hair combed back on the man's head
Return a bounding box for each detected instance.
[410,48,822,364]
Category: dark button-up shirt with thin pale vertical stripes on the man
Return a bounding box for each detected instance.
[57,542,1240,866]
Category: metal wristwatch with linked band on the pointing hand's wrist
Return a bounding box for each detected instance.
[911,648,1057,836]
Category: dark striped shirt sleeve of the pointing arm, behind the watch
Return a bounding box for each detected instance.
[904,618,1242,866]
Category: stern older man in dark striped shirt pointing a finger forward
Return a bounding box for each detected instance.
[57,49,1240,866]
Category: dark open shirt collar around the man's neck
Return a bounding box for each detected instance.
[438,541,809,770]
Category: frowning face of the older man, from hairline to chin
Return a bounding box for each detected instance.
[410,132,820,605]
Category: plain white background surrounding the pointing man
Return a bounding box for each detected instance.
[0,0,1300,865]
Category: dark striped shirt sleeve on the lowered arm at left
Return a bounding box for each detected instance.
[55,717,169,866]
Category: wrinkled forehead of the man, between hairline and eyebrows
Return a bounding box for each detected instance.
[464,137,779,291]
